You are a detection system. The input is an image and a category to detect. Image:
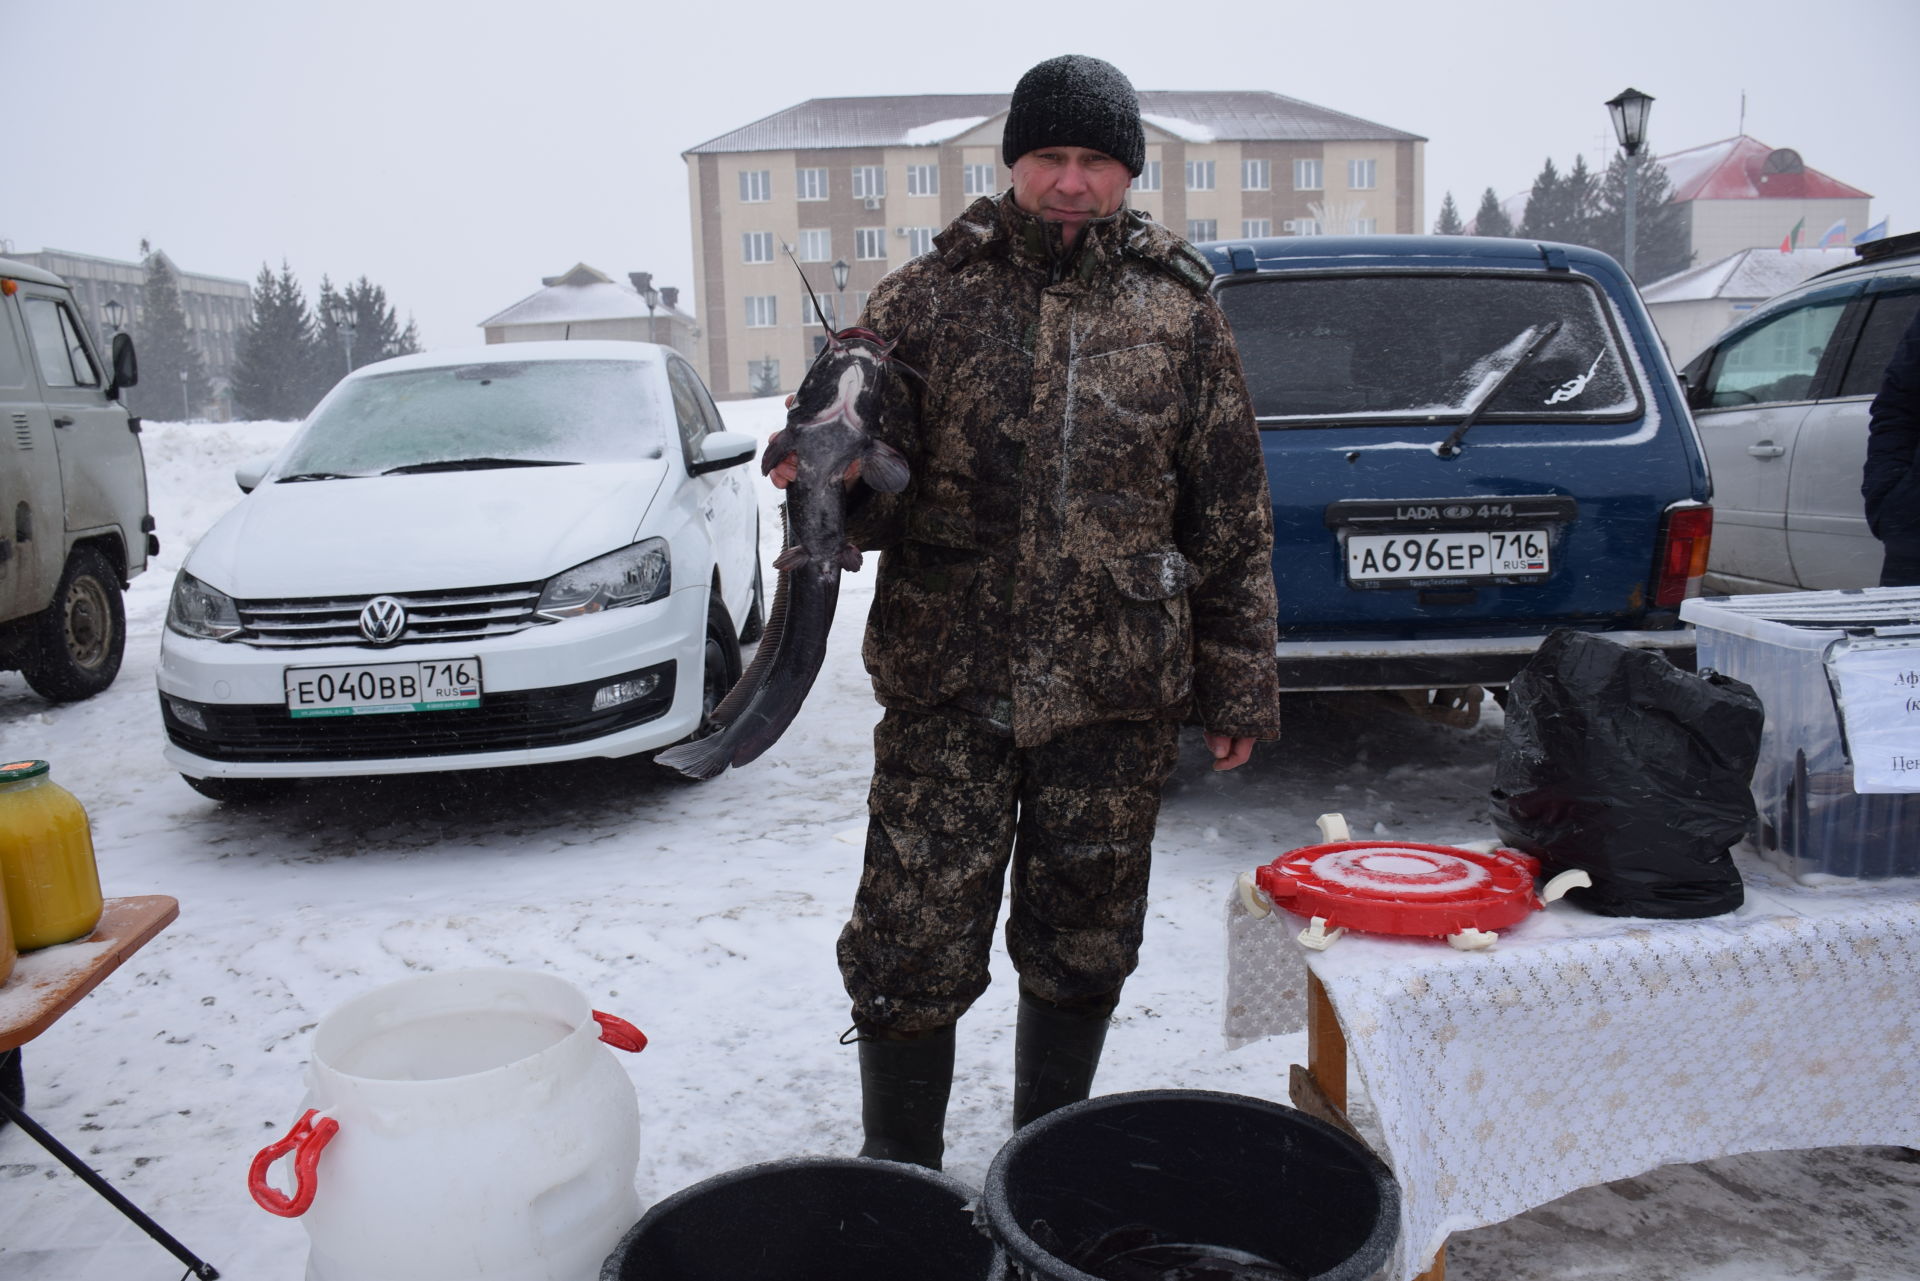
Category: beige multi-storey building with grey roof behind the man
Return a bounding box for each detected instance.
[684,90,1427,398]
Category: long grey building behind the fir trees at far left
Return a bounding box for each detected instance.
[8,250,253,419]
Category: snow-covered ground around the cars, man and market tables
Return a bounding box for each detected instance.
[0,401,1920,1281]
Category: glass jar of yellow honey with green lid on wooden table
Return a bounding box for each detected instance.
[0,761,102,953]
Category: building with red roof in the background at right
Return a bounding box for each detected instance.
[1661,134,1872,265]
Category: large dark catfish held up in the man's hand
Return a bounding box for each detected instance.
[657,328,906,778]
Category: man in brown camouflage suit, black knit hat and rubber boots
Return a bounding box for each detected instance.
[776,56,1279,1168]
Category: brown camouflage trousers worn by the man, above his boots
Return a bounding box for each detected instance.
[839,709,1179,1031]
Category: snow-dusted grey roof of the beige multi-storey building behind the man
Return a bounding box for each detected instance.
[685,90,1425,156]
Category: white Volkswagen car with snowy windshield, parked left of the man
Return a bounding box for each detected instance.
[159,342,760,801]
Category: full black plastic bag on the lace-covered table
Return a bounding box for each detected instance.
[1492,628,1764,918]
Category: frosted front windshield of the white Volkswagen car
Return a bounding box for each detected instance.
[278,361,666,480]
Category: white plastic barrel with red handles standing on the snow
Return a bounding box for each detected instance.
[250,970,645,1281]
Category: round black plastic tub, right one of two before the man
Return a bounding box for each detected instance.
[983,1089,1400,1281]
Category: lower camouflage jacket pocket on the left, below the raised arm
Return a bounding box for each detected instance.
[864,540,979,707]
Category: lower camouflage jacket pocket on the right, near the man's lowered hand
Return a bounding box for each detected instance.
[1089,547,1194,711]
